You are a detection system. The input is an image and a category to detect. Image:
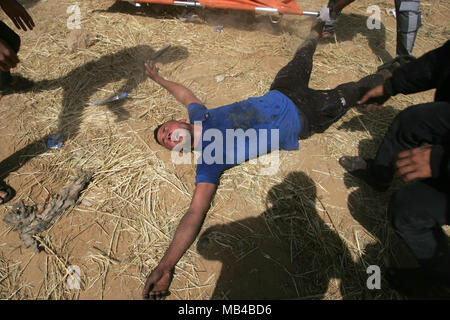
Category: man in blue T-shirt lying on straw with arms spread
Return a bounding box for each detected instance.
[142,23,390,299]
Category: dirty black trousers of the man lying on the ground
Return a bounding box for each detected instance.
[270,24,384,139]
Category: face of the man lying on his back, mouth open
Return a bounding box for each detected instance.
[156,120,191,150]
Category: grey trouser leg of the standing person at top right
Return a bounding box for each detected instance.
[395,0,422,56]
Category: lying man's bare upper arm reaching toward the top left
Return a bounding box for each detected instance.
[145,63,203,107]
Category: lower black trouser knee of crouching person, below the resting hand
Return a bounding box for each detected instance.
[388,179,450,286]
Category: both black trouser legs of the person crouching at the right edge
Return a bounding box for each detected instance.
[371,102,450,285]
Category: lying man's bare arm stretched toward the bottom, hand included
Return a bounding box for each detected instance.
[142,183,217,300]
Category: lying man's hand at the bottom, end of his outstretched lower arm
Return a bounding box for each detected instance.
[142,268,173,300]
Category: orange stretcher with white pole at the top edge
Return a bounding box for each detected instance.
[118,0,319,16]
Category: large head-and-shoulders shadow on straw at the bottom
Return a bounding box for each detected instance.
[197,172,386,299]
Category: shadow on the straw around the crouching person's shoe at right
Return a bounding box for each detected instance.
[338,106,428,297]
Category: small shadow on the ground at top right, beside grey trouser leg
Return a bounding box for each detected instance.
[335,13,393,63]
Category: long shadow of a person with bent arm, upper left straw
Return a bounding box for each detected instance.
[0,45,188,178]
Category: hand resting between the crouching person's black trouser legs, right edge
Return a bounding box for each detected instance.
[395,146,432,182]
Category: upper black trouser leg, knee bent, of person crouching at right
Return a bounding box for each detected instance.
[370,102,450,186]
